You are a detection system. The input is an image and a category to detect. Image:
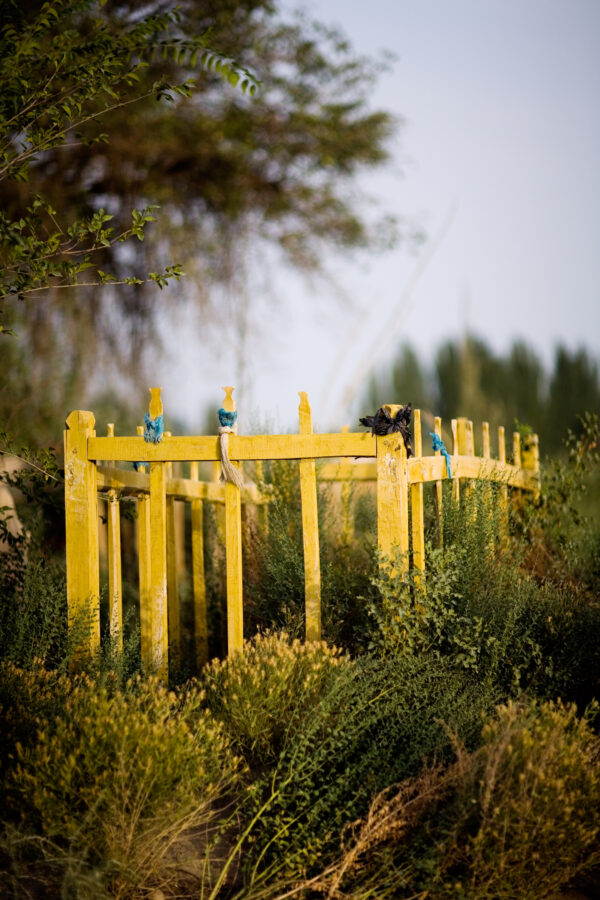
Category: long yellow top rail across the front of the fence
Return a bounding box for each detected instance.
[88,432,377,462]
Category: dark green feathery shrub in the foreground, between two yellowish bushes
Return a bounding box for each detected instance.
[241,655,494,882]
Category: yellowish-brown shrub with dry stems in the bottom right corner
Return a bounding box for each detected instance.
[306,702,600,900]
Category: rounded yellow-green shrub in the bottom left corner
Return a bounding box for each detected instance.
[4,674,238,900]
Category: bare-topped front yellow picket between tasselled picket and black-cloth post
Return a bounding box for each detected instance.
[298,391,321,641]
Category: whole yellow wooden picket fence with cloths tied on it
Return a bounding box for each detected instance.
[65,389,539,675]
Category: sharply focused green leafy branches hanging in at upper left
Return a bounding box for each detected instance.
[0,0,256,330]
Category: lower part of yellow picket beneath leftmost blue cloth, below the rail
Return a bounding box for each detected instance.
[150,462,169,679]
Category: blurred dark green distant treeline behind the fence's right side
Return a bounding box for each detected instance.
[361,336,600,455]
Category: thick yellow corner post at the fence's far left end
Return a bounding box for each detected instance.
[64,410,100,657]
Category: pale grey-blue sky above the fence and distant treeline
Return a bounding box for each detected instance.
[156,0,600,432]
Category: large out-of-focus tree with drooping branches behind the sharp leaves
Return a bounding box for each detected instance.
[0,0,396,443]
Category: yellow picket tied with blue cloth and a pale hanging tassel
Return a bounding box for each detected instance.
[222,386,244,655]
